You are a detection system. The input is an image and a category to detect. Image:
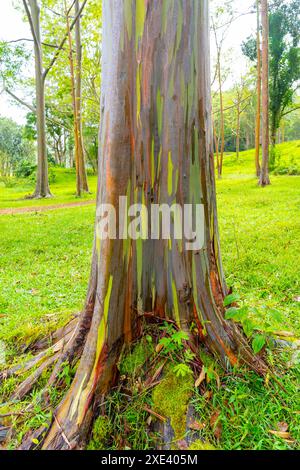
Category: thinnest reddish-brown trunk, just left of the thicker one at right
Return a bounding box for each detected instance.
[255,0,261,177]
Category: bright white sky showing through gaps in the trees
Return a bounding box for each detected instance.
[0,0,256,124]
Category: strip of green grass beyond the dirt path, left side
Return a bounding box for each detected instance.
[0,168,97,209]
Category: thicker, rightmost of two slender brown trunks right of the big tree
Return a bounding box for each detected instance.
[259,0,270,186]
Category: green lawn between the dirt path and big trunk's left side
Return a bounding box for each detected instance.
[0,206,95,348]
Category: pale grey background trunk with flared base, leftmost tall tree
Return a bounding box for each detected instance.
[29,0,51,198]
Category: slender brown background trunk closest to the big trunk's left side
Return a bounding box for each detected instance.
[75,0,89,192]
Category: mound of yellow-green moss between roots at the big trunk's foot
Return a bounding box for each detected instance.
[153,371,193,440]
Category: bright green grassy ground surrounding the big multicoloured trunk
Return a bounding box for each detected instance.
[0,142,300,449]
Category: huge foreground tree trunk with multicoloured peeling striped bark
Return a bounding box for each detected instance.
[44,0,264,449]
